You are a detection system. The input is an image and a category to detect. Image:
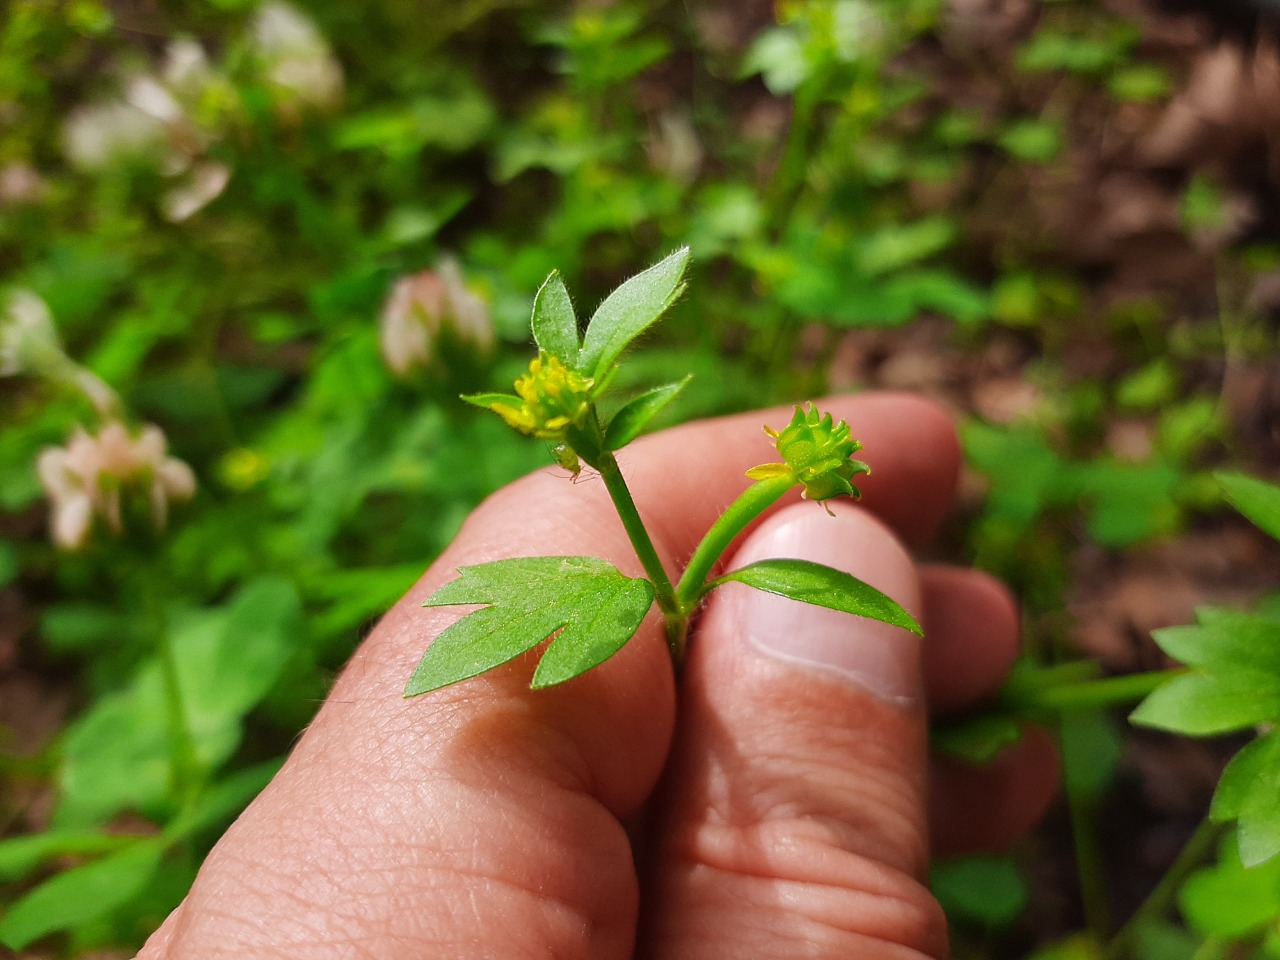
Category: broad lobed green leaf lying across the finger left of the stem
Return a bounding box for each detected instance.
[404,557,653,696]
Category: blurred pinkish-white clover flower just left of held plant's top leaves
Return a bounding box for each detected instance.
[379,257,494,376]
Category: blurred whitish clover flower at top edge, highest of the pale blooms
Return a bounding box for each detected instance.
[251,0,343,114]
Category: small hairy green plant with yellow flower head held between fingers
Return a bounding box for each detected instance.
[404,247,920,696]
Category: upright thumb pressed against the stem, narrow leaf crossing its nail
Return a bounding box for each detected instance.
[645,504,946,960]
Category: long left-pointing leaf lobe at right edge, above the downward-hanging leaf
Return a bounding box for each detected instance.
[1129,668,1280,736]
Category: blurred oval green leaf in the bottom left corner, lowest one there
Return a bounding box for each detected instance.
[0,837,165,950]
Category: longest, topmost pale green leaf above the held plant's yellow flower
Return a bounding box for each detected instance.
[577,247,689,380]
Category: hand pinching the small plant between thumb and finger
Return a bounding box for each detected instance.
[140,394,1055,960]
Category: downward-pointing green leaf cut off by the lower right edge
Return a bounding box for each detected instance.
[1210,731,1280,867]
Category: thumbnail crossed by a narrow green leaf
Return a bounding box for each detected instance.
[723,503,922,704]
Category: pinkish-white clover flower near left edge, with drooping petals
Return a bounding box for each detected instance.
[36,421,196,549]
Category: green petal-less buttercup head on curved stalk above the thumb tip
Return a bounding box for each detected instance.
[746,403,870,502]
